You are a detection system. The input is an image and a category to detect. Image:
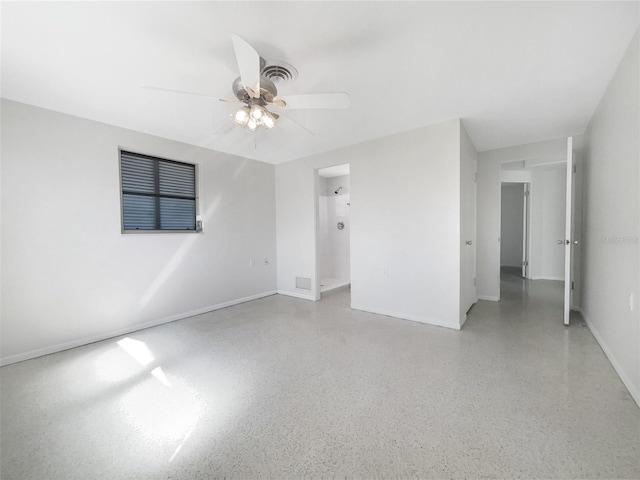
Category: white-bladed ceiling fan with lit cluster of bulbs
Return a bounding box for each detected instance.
[143,34,351,133]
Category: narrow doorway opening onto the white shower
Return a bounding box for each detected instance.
[316,164,351,296]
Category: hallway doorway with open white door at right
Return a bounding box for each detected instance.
[499,137,581,325]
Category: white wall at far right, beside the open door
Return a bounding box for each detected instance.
[582,32,640,404]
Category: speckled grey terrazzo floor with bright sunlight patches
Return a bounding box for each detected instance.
[0,277,640,480]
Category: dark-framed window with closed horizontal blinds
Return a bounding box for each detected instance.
[120,150,198,232]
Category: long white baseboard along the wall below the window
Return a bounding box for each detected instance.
[0,290,276,367]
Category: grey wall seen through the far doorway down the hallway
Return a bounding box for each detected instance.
[500,183,524,267]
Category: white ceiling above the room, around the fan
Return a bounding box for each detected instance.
[1,1,640,163]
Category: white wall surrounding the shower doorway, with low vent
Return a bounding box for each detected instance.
[276,120,460,328]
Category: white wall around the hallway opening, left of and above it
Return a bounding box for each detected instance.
[477,138,567,301]
